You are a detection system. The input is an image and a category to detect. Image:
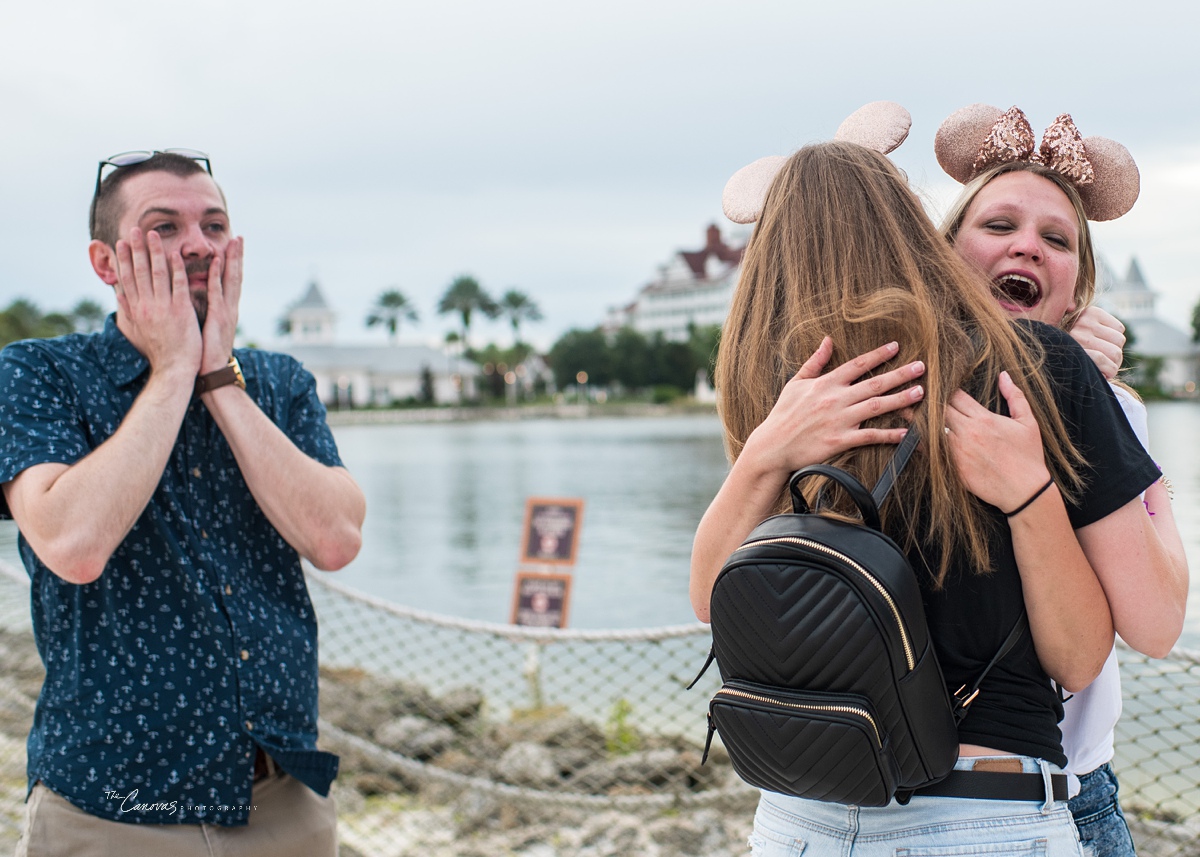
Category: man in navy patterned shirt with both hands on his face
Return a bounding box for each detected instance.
[0,151,365,855]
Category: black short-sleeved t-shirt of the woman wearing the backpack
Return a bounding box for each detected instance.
[910,323,1159,766]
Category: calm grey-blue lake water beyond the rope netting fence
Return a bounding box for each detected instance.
[0,402,1200,648]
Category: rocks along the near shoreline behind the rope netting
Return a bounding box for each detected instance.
[0,629,755,857]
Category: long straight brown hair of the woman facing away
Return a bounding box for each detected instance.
[716,142,1082,586]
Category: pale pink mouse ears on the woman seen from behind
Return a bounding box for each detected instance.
[721,101,912,223]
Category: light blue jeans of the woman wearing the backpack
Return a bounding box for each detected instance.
[750,756,1084,857]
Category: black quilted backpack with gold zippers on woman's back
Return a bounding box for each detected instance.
[692,430,1027,807]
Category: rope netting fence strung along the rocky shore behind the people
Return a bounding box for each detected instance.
[0,564,1200,856]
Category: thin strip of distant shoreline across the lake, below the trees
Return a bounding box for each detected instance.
[329,401,716,426]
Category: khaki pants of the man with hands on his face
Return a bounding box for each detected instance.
[17,774,337,857]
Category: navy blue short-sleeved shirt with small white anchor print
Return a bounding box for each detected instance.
[0,316,341,825]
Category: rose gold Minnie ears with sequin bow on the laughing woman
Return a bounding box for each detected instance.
[934,104,1141,221]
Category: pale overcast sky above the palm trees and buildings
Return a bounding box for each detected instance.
[0,0,1200,346]
